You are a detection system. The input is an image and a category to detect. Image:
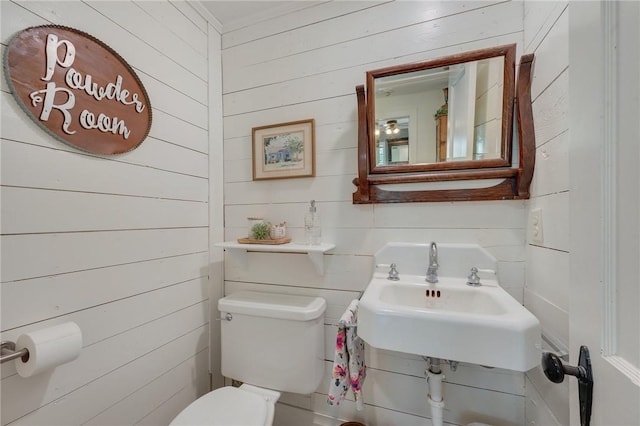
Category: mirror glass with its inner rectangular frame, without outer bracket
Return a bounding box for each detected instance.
[367,46,515,173]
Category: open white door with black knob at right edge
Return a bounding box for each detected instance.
[569,1,640,426]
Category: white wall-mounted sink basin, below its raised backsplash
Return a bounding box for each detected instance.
[358,272,540,371]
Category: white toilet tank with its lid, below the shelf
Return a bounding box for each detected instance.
[218,291,327,394]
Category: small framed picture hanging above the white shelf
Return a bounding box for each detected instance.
[252,119,316,180]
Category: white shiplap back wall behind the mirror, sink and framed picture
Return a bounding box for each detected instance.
[222,1,528,426]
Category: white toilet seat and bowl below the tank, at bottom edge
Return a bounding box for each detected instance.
[171,385,274,426]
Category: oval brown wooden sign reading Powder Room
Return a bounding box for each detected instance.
[4,25,151,154]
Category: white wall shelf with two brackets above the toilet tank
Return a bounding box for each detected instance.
[215,241,336,275]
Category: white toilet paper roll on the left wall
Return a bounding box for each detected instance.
[16,322,82,377]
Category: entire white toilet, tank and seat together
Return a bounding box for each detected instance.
[171,291,327,426]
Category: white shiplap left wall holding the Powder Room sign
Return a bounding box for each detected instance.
[0,1,222,425]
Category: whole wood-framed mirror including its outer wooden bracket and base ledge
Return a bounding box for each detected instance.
[353,45,535,204]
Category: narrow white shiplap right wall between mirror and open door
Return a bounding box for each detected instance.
[524,1,570,426]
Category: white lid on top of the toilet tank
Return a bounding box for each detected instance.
[218,291,327,321]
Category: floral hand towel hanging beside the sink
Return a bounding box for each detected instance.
[327,300,366,411]
